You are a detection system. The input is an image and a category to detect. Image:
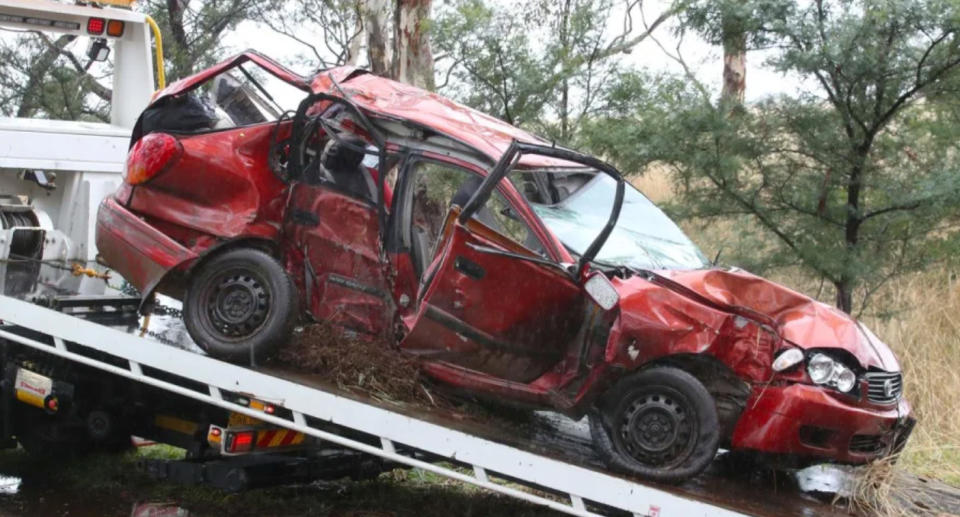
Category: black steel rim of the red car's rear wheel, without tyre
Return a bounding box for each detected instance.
[200,269,271,340]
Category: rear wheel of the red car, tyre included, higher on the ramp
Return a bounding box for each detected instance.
[183,248,299,362]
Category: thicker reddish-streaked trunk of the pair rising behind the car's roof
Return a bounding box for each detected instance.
[393,0,434,90]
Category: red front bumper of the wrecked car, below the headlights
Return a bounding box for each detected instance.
[731,384,914,464]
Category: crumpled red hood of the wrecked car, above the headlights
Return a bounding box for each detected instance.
[658,269,900,371]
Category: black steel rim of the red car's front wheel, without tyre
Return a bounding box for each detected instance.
[613,387,698,469]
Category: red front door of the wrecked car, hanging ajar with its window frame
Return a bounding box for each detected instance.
[401,157,585,383]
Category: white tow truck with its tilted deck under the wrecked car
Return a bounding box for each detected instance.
[0,0,892,517]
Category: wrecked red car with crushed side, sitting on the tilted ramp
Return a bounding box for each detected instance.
[97,52,913,481]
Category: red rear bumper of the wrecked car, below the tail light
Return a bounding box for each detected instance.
[97,198,197,296]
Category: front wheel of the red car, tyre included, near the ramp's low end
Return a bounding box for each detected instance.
[590,367,719,483]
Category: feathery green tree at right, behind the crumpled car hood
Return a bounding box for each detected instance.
[589,1,960,311]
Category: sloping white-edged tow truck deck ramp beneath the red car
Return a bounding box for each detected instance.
[0,296,841,517]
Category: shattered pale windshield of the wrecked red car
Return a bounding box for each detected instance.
[531,173,708,269]
